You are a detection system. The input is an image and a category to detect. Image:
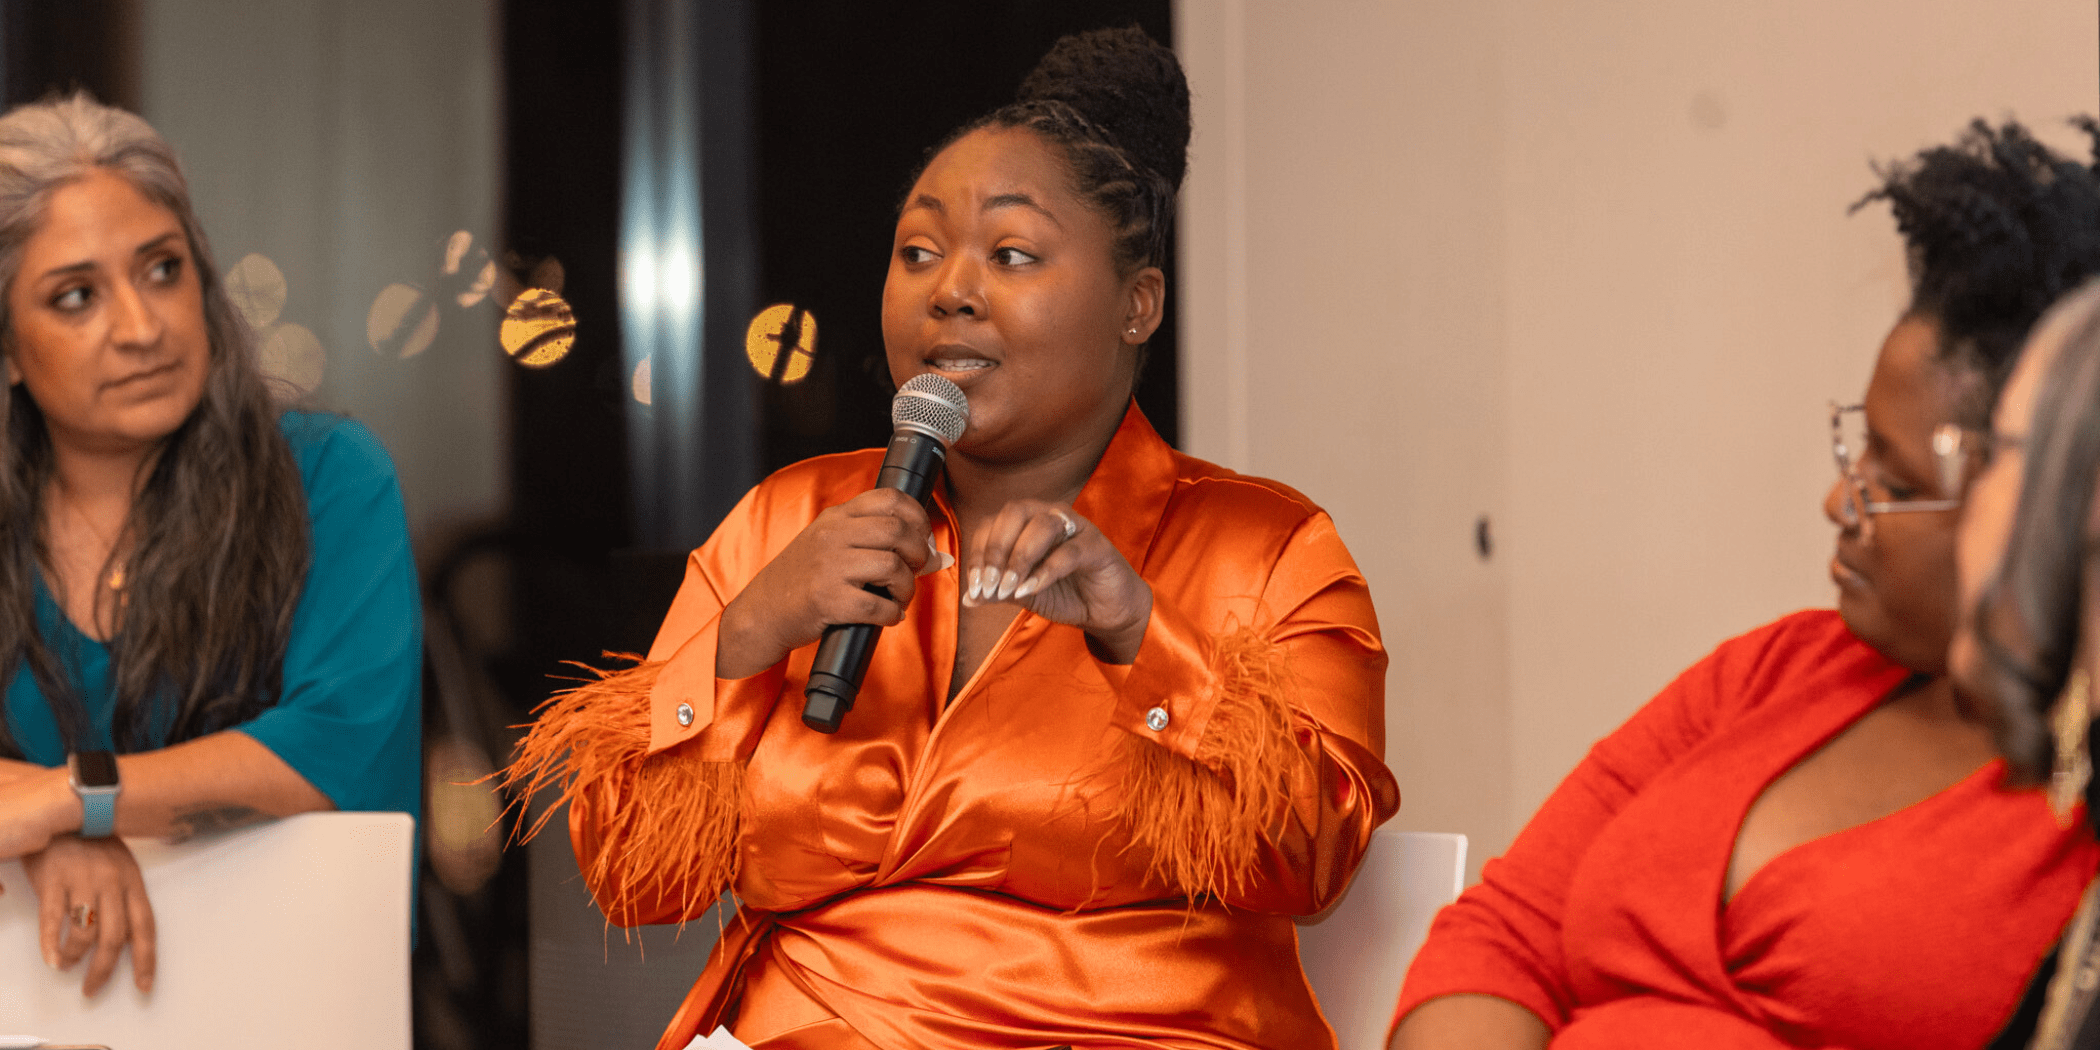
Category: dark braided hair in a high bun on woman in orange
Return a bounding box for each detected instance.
[907,25,1189,273]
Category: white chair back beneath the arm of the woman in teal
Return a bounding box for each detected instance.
[0,813,416,1050]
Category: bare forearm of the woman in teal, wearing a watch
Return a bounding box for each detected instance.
[0,731,336,855]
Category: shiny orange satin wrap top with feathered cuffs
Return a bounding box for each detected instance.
[571,405,1399,1050]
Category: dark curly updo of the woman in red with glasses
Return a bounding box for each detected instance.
[1852,118,2100,428]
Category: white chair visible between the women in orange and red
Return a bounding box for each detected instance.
[1298,830,1466,1050]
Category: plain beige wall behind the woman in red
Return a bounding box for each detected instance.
[1176,0,2100,869]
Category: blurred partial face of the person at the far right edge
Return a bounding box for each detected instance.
[1974,279,2100,785]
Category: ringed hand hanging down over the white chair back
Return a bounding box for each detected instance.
[21,836,155,995]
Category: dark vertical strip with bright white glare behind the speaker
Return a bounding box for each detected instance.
[620,0,758,552]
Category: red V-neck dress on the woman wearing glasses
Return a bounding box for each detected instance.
[1397,611,2100,1050]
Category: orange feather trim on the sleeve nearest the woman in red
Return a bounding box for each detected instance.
[1117,628,1304,901]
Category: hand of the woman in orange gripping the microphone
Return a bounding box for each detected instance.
[714,489,932,678]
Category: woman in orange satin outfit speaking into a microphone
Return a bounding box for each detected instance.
[510,29,1399,1050]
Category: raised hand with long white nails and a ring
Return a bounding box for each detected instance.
[962,500,1153,664]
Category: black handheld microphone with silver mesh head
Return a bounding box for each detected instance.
[802,372,970,733]
